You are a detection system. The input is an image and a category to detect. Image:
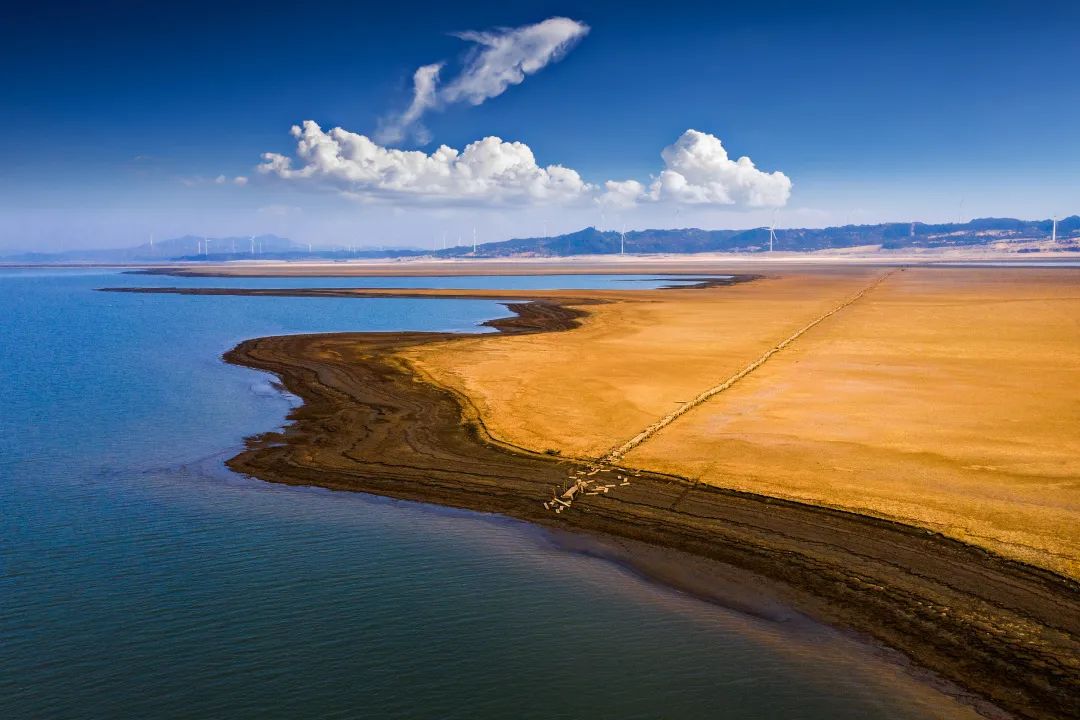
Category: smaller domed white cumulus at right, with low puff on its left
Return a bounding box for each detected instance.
[599,130,792,208]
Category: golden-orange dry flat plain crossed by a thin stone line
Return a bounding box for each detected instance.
[409,266,1080,578]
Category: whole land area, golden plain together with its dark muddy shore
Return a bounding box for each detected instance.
[111,264,1080,718]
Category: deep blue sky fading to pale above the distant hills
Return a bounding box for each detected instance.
[0,0,1080,249]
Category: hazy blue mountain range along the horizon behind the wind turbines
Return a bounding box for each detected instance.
[0,220,1080,263]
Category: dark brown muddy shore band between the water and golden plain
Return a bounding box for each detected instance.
[107,288,1080,718]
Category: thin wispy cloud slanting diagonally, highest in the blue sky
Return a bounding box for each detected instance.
[375,17,589,145]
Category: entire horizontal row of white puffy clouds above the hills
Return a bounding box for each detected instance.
[257,120,792,209]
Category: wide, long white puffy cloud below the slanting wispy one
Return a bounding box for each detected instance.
[258,120,592,205]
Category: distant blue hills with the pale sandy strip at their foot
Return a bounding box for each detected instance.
[8,215,1080,264]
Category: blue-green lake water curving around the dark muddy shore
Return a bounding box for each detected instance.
[0,271,980,720]
